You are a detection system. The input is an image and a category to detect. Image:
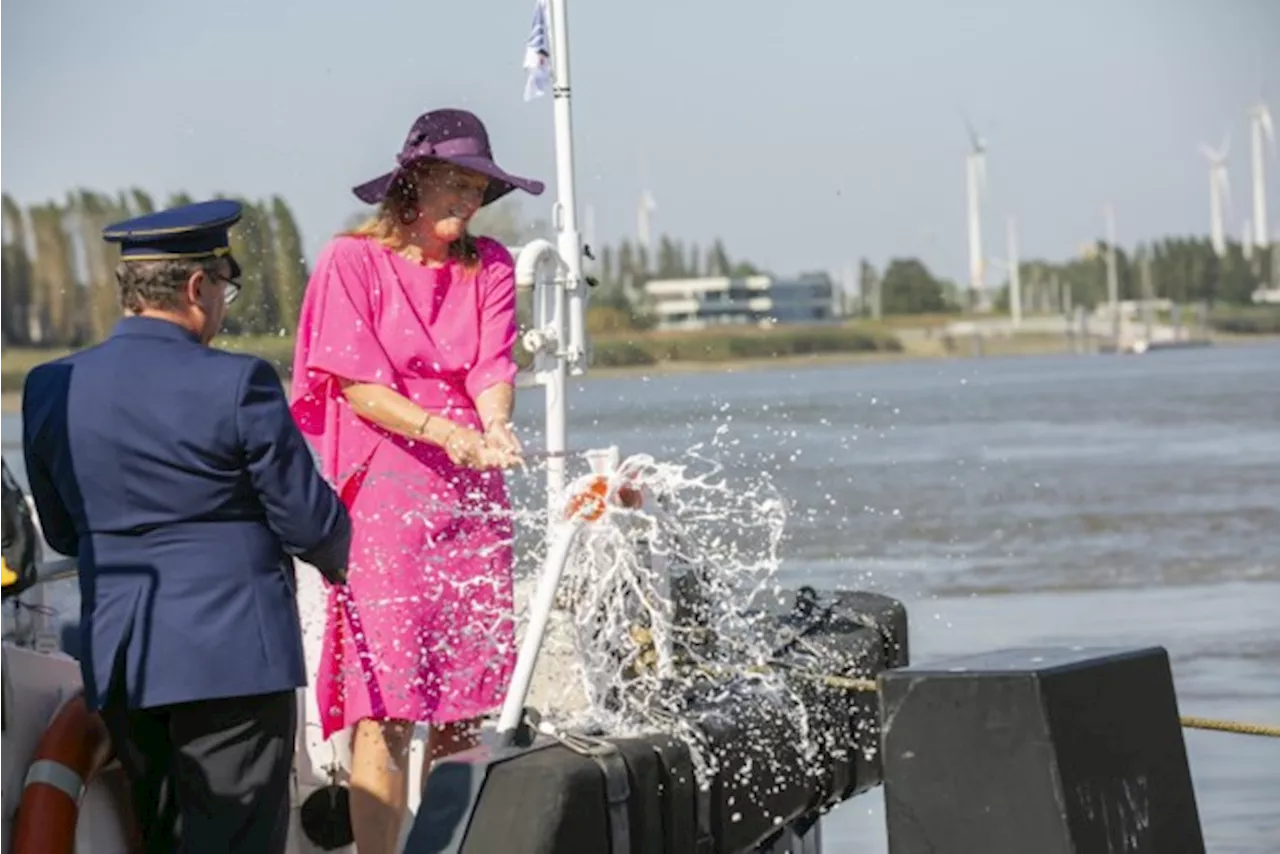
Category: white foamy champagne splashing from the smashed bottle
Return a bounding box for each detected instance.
[550,455,834,785]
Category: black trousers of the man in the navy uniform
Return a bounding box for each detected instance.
[101,691,297,854]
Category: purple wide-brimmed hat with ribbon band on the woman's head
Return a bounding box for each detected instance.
[352,110,545,205]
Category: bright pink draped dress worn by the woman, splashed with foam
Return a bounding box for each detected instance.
[292,237,516,737]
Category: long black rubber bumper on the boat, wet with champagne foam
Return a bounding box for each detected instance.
[403,588,908,854]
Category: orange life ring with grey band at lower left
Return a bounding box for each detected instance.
[13,693,137,854]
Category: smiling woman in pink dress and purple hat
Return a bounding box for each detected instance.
[292,110,543,854]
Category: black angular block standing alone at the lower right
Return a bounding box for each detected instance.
[879,647,1204,854]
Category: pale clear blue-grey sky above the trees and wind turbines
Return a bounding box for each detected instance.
[0,0,1280,286]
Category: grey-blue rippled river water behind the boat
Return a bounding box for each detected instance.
[0,346,1280,854]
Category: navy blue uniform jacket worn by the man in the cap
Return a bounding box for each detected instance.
[22,318,351,708]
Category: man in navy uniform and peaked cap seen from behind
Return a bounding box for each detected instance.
[22,200,351,854]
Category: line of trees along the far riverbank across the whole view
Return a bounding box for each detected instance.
[0,188,1280,347]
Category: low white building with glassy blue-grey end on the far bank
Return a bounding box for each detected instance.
[644,273,836,329]
